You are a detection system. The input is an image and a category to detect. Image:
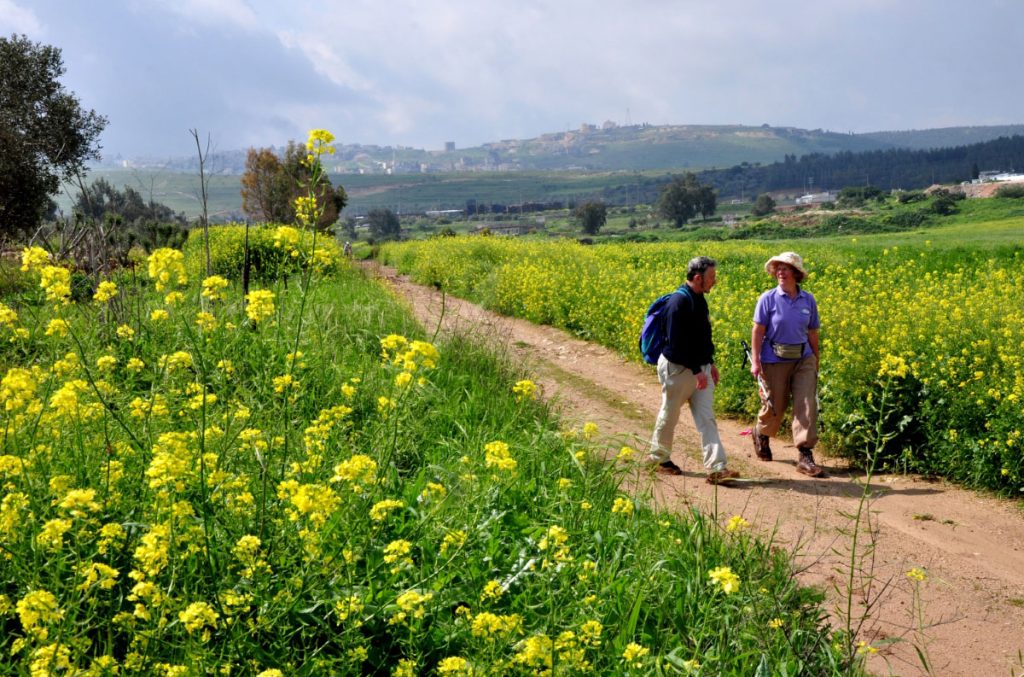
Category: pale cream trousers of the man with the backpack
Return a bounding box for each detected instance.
[648,355,725,472]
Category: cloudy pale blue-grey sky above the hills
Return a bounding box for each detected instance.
[0,0,1024,157]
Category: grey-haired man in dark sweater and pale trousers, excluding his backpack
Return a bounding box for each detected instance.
[648,256,739,484]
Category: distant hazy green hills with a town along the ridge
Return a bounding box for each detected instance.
[64,124,1024,221]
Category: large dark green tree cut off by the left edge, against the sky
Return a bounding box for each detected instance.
[0,35,106,236]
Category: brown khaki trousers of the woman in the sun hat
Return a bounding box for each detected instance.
[754,355,818,449]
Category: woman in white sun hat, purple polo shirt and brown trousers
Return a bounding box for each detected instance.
[751,252,824,477]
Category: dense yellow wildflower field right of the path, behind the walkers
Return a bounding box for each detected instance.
[382,238,1024,495]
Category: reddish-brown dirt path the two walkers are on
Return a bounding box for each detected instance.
[369,264,1024,677]
